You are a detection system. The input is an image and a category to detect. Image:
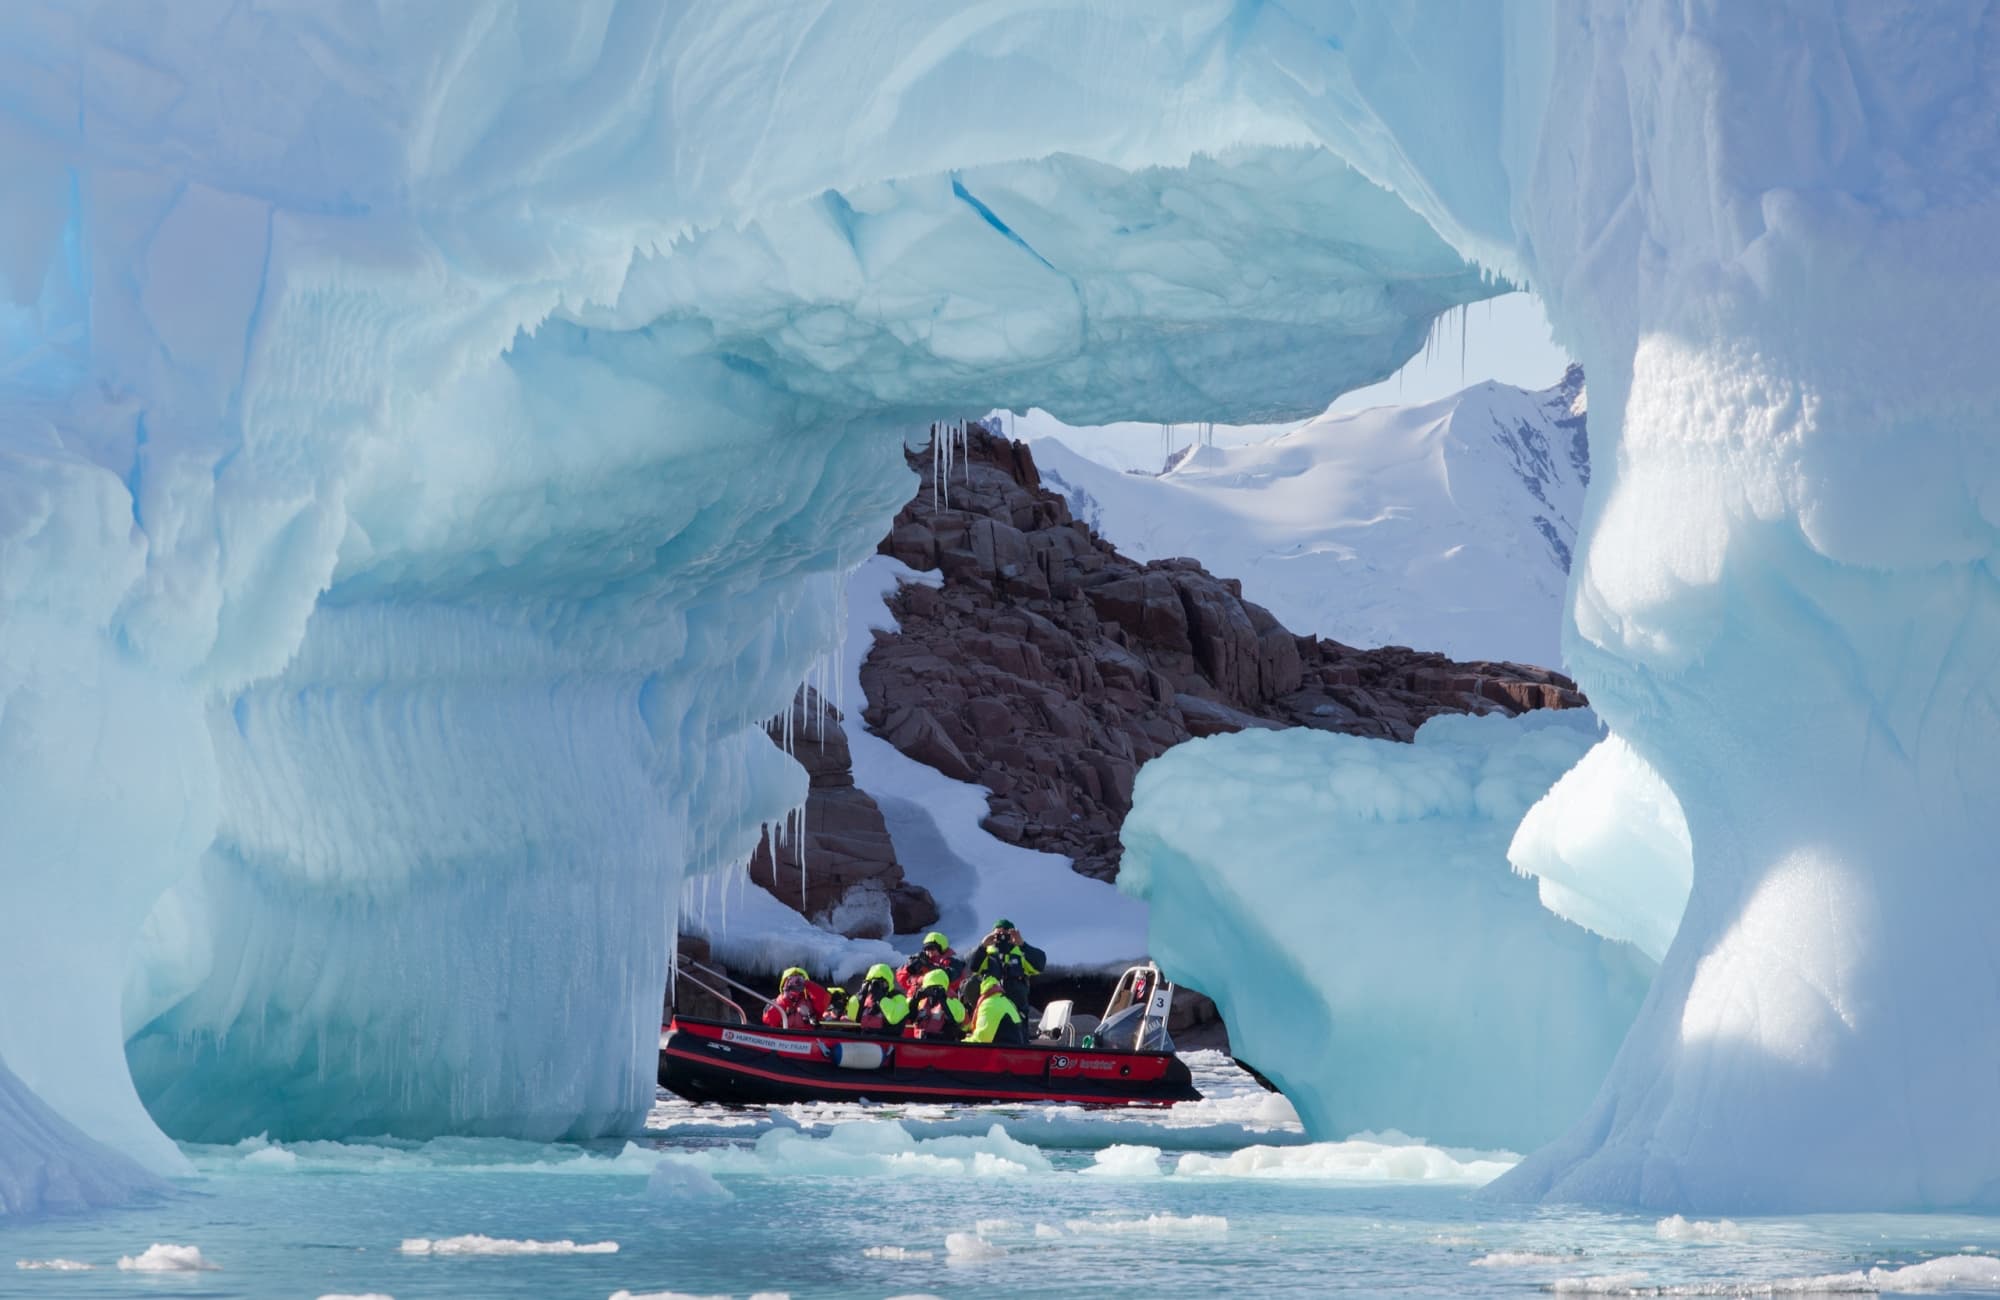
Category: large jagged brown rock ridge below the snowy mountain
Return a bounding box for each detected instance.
[868,426,1584,880]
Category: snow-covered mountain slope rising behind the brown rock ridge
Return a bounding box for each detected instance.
[1032,366,1590,666]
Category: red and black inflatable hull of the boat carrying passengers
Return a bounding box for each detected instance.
[660,1016,1202,1106]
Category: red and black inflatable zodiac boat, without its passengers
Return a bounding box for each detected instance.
[660,966,1202,1106]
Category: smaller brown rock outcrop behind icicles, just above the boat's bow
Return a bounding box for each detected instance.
[750,686,940,938]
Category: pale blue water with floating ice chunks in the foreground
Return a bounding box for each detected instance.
[0,1054,2000,1300]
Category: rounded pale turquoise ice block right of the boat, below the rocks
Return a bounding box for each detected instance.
[1118,710,1652,1150]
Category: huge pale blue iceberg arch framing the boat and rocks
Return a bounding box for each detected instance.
[0,0,2000,1208]
